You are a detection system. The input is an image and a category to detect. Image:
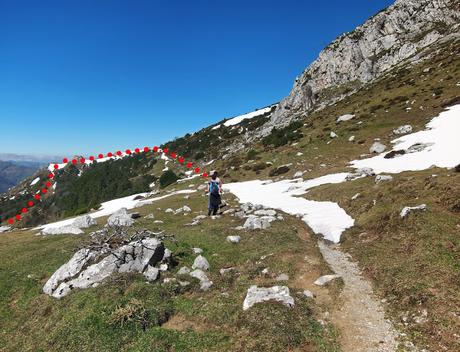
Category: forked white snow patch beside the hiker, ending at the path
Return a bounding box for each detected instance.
[224,173,354,243]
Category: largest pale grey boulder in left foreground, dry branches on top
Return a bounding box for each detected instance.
[43,238,164,298]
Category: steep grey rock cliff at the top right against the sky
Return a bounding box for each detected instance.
[262,0,460,134]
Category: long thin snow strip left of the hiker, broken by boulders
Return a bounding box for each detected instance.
[39,189,196,234]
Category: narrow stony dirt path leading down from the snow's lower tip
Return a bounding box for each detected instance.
[318,241,398,352]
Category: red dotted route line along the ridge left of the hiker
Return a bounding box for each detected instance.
[1,146,208,225]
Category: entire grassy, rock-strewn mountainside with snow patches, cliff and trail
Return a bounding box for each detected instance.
[0,0,460,352]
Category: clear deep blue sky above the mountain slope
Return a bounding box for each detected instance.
[0,0,393,155]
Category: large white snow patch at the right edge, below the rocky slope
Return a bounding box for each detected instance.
[351,105,460,174]
